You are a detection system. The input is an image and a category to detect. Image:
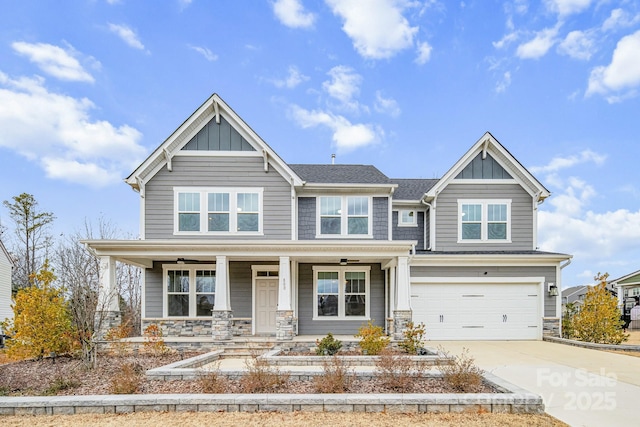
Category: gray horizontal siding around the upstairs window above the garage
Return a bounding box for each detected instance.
[435,184,535,251]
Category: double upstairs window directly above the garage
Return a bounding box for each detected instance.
[458,200,511,243]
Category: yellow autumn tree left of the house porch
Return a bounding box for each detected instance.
[5,261,74,359]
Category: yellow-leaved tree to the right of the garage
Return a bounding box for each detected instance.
[571,273,629,344]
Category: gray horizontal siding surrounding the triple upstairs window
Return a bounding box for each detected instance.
[144,156,292,240]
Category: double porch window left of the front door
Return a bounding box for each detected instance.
[163,264,216,317]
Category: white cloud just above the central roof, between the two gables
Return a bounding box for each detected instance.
[290,105,381,153]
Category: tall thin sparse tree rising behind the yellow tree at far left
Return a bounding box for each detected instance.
[2,193,55,289]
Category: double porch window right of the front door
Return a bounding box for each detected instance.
[313,266,370,320]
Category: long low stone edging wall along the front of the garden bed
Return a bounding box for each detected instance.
[0,373,544,415]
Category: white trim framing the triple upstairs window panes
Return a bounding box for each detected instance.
[173,187,264,236]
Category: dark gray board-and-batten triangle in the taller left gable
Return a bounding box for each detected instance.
[182,117,256,151]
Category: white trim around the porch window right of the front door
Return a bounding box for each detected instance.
[312,265,371,322]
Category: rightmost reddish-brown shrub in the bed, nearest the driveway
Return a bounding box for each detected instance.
[438,347,483,393]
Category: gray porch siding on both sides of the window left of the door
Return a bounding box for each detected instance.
[142,261,273,318]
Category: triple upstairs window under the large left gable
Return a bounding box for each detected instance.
[174,188,263,234]
